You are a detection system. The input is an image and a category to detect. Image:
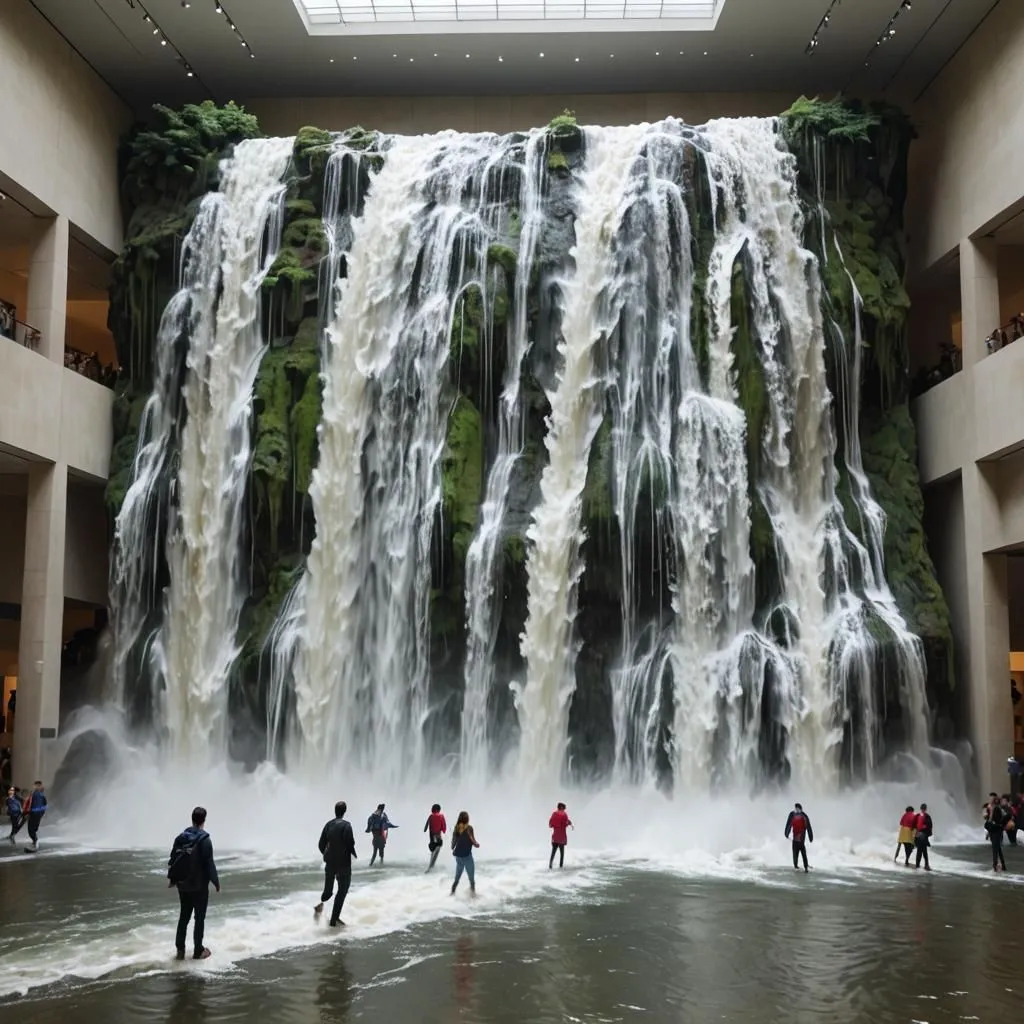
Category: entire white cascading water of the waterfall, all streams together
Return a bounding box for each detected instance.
[114,119,927,791]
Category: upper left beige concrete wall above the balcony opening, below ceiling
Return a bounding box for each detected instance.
[0,0,132,251]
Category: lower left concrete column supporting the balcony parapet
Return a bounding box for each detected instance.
[13,463,68,783]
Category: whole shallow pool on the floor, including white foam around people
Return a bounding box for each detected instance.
[0,821,1024,1024]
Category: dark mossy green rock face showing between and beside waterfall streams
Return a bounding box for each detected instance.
[108,99,953,774]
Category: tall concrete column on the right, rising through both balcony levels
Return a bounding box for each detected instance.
[959,239,1014,793]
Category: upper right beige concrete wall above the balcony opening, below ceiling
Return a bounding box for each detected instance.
[908,0,1024,271]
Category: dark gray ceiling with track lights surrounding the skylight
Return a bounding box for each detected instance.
[29,0,999,111]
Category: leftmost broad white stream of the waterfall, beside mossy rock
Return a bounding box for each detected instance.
[156,138,292,757]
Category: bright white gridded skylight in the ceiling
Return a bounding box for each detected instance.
[295,0,725,35]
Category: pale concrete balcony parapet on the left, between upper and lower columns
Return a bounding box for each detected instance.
[0,338,114,480]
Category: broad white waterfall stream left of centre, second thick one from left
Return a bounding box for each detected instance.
[295,133,524,776]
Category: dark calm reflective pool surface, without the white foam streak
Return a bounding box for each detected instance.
[6,844,1024,1024]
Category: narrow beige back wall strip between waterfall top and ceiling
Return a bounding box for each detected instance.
[246,92,796,135]
